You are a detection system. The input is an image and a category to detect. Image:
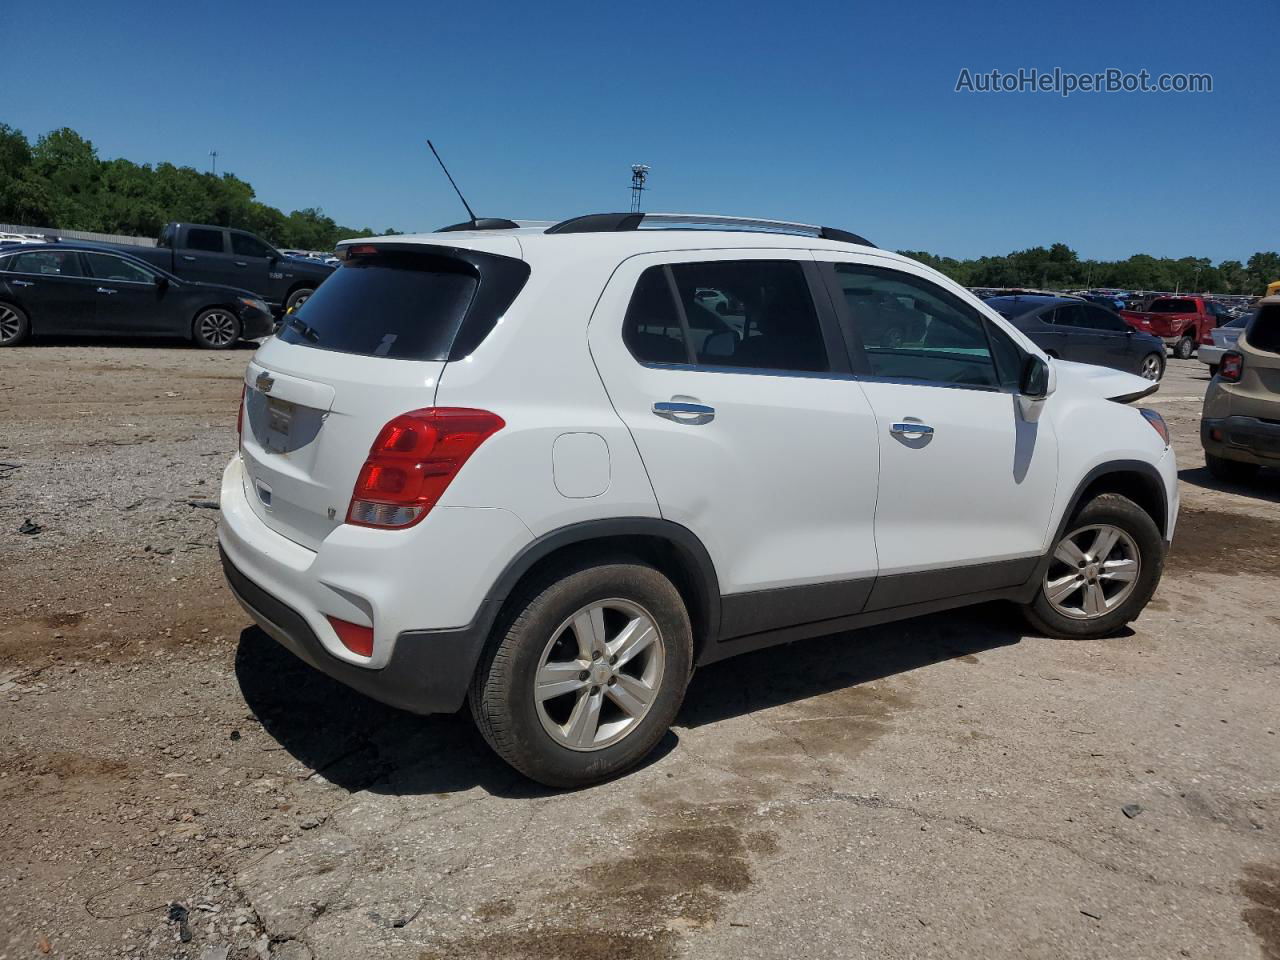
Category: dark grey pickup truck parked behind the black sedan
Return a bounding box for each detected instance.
[114,223,334,311]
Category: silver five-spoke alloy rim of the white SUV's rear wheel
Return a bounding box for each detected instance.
[534,599,666,751]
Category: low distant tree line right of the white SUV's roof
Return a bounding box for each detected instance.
[900,243,1280,297]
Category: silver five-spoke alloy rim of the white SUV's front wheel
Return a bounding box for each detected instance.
[1043,524,1142,620]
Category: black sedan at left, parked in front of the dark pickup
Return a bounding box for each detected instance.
[0,243,274,349]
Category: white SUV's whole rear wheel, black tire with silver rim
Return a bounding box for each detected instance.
[468,558,692,787]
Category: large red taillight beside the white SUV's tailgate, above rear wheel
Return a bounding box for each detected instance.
[347,407,506,527]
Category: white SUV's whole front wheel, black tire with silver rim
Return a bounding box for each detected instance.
[1023,493,1165,640]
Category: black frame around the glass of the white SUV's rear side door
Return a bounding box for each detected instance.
[622,257,856,380]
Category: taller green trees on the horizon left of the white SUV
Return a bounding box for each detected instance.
[0,123,397,250]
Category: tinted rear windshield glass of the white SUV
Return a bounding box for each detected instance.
[279,251,529,361]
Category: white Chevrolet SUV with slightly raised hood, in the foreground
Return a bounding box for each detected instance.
[219,214,1178,786]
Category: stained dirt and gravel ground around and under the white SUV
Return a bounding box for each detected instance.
[0,344,1280,960]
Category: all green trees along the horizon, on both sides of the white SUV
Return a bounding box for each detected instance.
[0,123,1280,289]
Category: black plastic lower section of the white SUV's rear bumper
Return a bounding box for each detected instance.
[219,549,498,713]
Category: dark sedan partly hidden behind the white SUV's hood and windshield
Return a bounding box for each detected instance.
[986,294,1165,380]
